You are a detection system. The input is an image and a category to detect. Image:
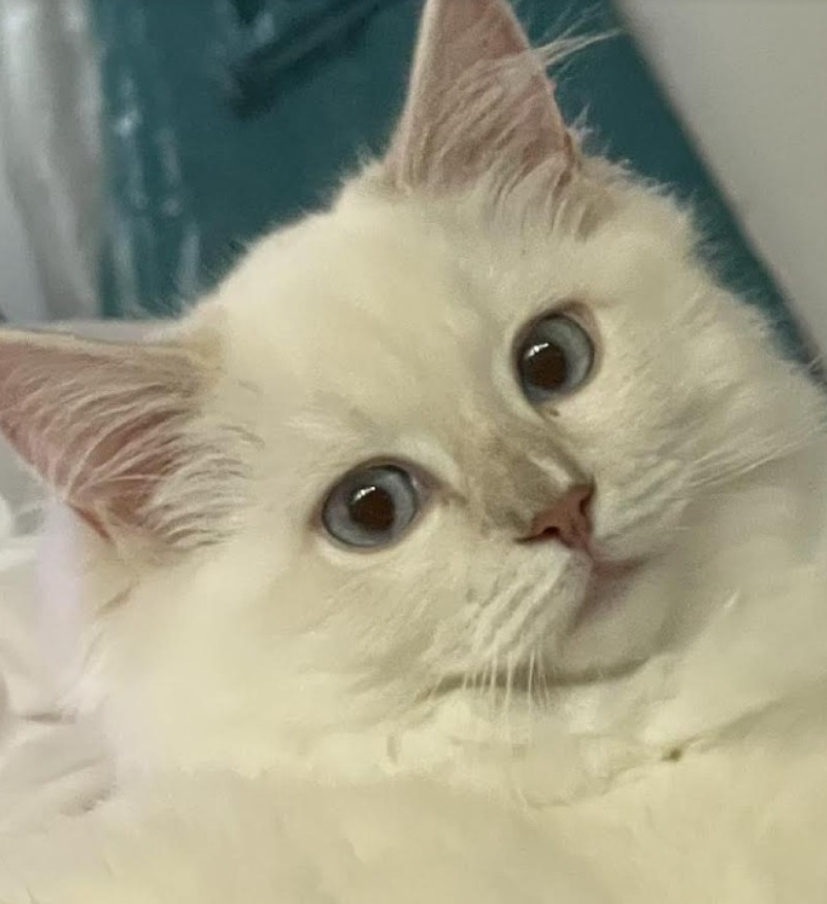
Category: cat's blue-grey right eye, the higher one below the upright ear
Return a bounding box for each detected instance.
[516,314,595,404]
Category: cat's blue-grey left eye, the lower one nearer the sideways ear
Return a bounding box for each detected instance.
[322,465,420,549]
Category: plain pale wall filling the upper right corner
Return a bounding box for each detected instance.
[619,0,827,350]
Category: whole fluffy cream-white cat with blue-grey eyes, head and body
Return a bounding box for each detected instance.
[0,0,827,904]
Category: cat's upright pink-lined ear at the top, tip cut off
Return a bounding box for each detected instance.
[384,0,577,192]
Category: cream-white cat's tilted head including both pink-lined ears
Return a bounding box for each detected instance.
[0,0,817,776]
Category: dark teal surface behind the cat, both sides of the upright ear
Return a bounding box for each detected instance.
[92,0,799,348]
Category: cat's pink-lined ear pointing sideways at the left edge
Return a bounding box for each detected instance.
[0,331,234,547]
